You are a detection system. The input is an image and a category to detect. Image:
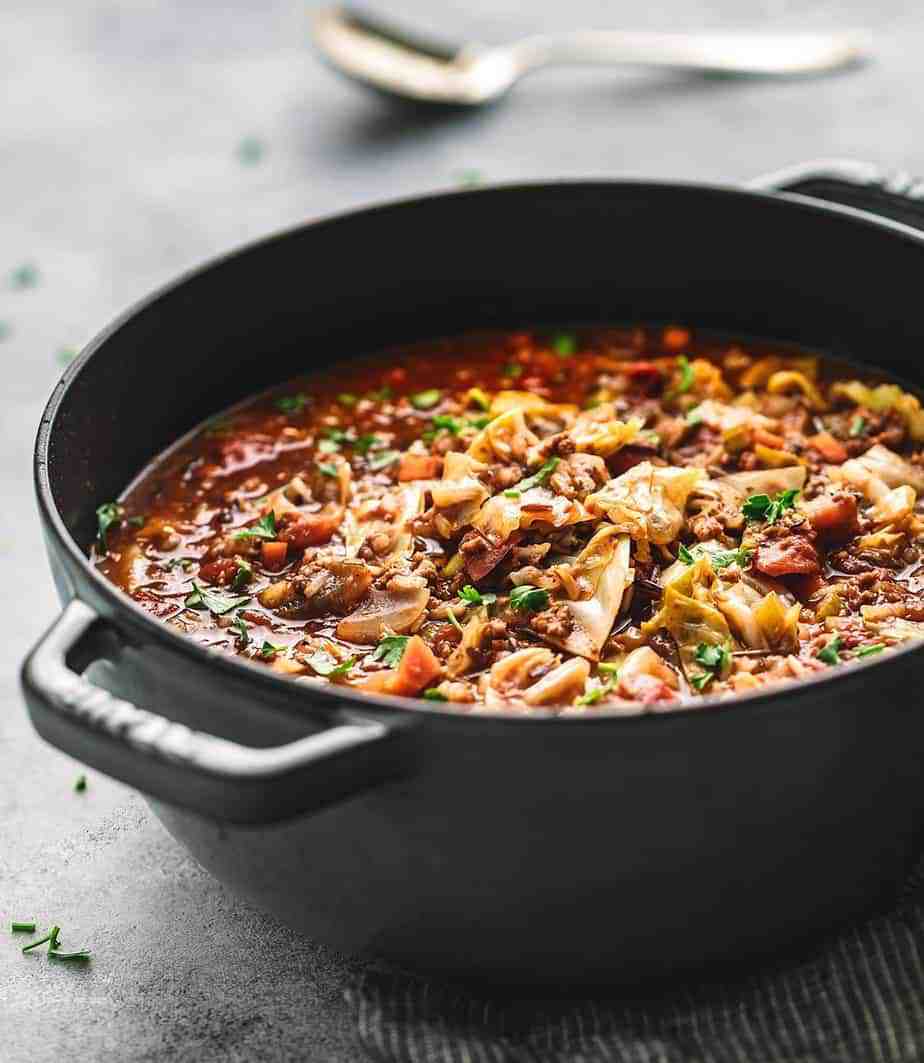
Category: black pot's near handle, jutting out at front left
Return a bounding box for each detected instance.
[22,600,403,824]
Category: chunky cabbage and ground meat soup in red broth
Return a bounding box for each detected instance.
[94,326,924,714]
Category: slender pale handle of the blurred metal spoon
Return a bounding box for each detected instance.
[504,30,868,77]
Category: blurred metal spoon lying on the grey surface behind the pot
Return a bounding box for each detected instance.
[314,7,867,106]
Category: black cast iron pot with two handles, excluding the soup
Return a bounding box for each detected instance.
[22,164,924,984]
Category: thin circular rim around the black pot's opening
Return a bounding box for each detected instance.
[33,178,924,729]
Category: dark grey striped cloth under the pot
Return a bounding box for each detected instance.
[348,870,924,1063]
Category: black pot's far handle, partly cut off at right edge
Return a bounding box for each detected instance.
[745,159,924,229]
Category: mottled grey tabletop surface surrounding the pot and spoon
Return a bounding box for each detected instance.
[0,0,924,1063]
